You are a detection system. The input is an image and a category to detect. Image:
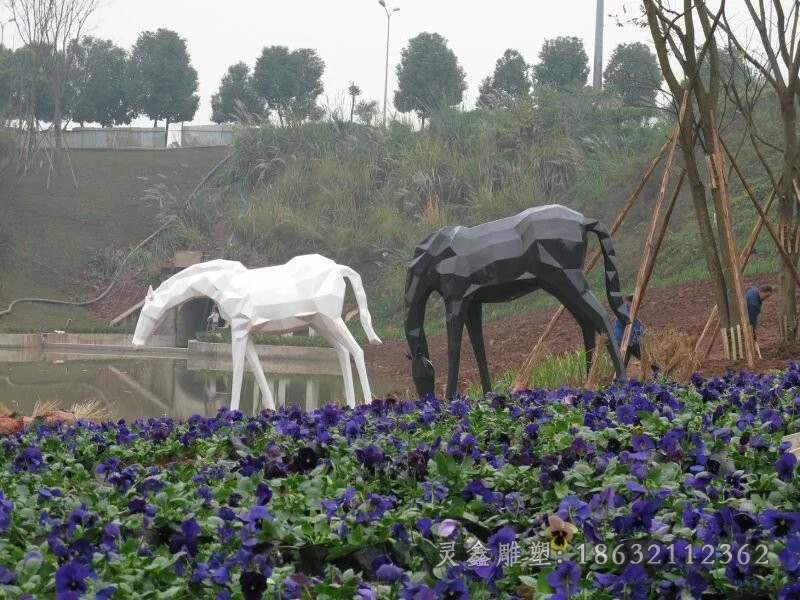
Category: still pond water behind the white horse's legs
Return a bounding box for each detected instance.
[0,355,390,421]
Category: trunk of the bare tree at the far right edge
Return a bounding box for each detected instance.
[778,91,798,340]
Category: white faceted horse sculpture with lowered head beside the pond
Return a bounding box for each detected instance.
[132,254,381,410]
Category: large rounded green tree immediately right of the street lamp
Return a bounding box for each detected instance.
[394,33,467,127]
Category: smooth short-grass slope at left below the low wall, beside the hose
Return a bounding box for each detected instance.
[0,148,228,331]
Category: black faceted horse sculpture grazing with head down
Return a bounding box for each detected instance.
[405,204,629,397]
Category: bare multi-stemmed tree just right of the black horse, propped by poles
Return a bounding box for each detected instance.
[644,0,747,336]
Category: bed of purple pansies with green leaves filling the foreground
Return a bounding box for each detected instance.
[0,363,800,599]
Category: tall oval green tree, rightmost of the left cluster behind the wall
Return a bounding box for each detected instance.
[129,29,200,139]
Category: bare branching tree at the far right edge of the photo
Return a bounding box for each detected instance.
[722,0,800,340]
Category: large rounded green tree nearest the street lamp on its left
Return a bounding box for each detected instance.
[253,46,325,125]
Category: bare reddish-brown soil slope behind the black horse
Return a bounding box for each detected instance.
[364,275,800,393]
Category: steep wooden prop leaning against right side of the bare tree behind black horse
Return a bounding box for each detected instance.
[711,110,756,369]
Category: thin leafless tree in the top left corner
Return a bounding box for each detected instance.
[4,0,99,149]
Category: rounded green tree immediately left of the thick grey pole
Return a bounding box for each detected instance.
[533,36,589,91]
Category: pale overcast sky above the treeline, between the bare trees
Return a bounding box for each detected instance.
[5,0,764,124]
